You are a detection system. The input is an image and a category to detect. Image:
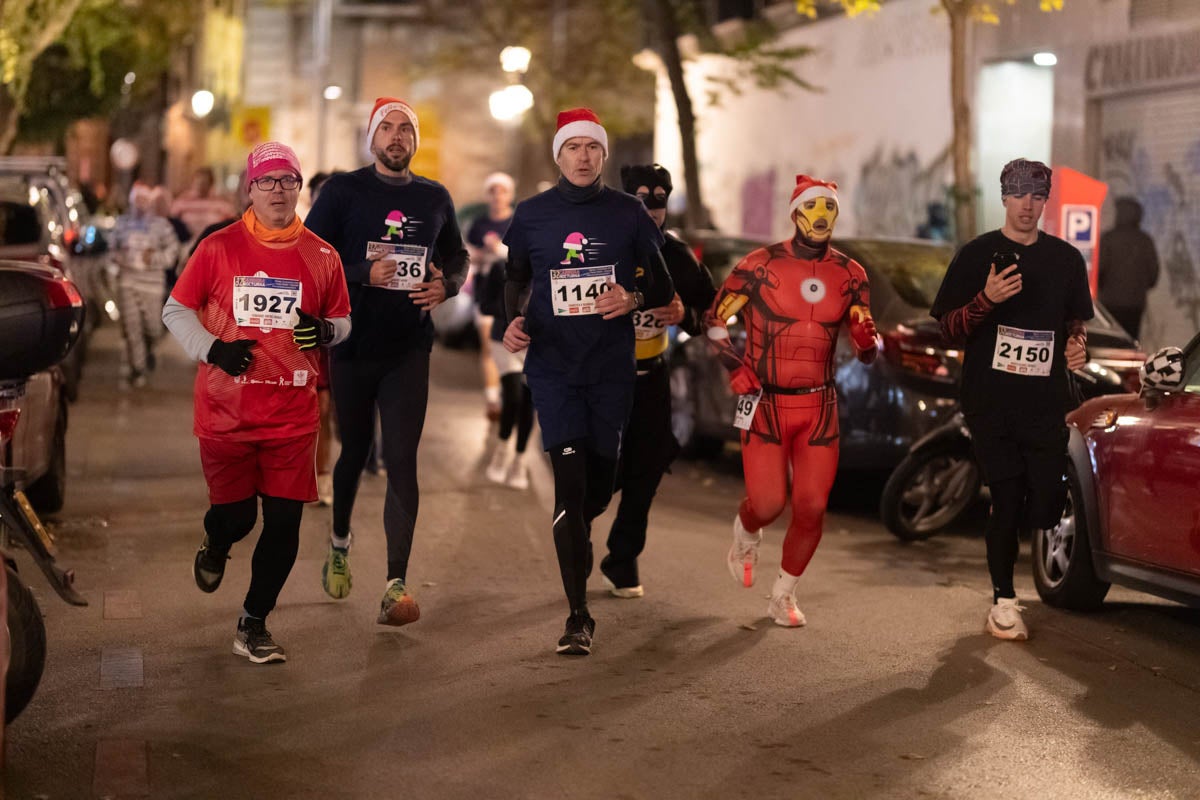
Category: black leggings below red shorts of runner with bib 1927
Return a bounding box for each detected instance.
[204,494,304,619]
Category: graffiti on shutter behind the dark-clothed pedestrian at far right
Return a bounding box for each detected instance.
[1102,130,1200,347]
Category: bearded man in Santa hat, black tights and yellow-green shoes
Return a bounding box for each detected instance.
[305,97,467,625]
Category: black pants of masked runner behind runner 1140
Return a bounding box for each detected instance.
[600,360,679,588]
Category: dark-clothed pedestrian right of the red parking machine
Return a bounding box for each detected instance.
[1097,197,1158,338]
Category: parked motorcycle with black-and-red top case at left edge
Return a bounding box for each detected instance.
[0,261,88,723]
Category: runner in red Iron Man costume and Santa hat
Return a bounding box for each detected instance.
[706,175,877,627]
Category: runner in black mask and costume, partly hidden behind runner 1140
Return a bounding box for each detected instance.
[600,164,716,597]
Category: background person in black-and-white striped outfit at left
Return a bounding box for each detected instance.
[110,181,179,389]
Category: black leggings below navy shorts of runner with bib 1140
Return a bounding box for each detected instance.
[550,439,617,613]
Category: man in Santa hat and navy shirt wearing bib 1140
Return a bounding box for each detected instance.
[504,108,674,655]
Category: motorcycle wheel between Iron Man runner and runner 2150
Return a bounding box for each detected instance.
[880,441,982,542]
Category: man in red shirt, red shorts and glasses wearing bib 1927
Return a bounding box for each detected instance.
[163,142,350,663]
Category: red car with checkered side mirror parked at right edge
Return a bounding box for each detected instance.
[1033,335,1200,610]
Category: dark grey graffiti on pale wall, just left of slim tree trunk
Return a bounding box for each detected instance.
[853,146,952,236]
